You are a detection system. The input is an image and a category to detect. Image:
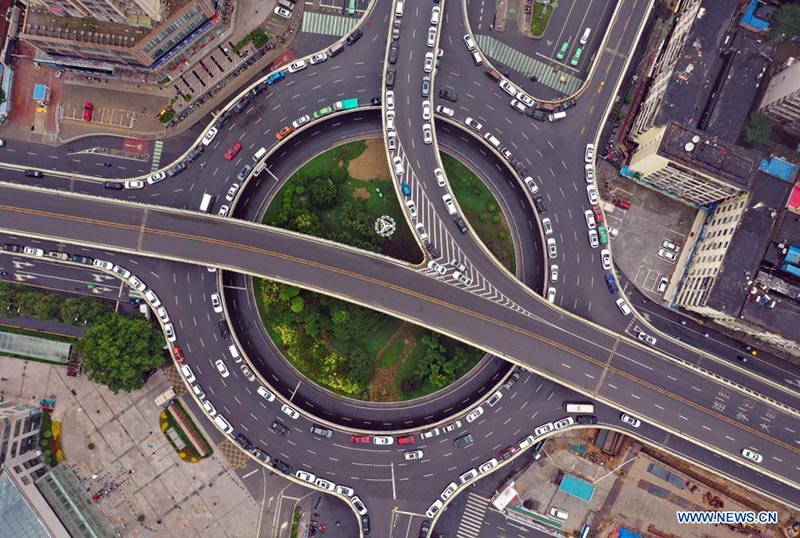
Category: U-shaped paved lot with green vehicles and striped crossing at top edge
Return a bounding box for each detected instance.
[467,0,615,99]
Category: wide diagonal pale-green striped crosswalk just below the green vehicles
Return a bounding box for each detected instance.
[475,34,584,95]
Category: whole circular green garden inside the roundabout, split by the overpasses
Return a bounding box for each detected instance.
[254,140,514,401]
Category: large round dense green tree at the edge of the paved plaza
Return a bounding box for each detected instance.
[76,312,164,394]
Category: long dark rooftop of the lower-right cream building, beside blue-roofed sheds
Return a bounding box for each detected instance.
[708,172,798,318]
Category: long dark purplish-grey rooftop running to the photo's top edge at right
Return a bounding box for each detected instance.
[655,0,739,126]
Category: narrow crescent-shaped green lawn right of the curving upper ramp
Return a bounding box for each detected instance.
[442,154,516,273]
